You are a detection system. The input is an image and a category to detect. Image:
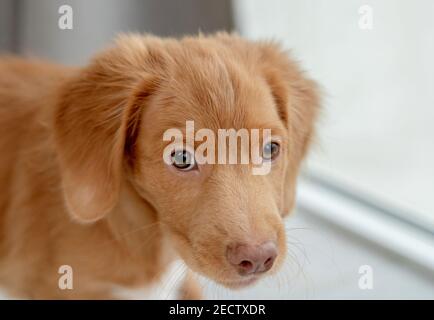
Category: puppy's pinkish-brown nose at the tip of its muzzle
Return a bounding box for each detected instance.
[227,241,277,276]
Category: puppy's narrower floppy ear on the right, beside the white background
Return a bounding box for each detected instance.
[261,43,320,213]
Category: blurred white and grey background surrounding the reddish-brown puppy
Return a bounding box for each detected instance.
[0,0,434,299]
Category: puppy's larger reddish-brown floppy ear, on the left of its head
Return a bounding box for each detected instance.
[54,39,164,222]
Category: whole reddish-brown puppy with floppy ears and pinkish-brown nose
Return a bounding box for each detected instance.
[0,33,319,299]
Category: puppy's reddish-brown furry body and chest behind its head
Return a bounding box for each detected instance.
[0,58,185,298]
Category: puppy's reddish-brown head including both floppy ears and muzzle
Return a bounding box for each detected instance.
[55,34,318,287]
